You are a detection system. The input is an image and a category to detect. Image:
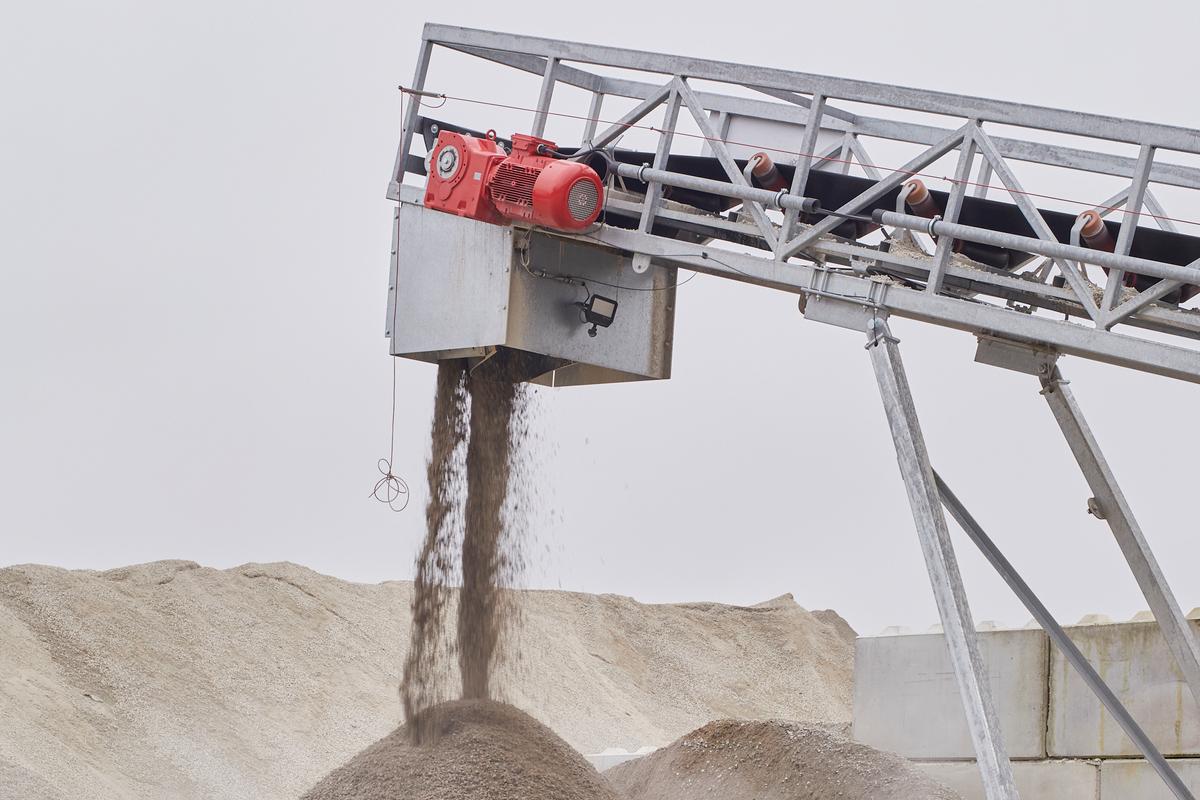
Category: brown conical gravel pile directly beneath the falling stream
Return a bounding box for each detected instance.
[302,699,618,800]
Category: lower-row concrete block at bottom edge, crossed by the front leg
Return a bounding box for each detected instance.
[917,762,1099,800]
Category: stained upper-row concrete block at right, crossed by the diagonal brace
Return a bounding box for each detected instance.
[1046,622,1200,758]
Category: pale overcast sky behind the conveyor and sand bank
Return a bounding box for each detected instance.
[0,0,1200,633]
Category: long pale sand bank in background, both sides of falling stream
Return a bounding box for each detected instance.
[0,561,853,800]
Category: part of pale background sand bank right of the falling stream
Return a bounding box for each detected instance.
[508,591,854,753]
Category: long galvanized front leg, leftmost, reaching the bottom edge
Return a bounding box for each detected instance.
[866,319,1018,800]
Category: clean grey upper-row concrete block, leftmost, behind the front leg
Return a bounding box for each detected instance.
[854,630,1049,760]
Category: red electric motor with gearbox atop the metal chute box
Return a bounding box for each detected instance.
[425,131,604,230]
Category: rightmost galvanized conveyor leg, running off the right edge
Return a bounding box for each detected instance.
[1040,365,1200,704]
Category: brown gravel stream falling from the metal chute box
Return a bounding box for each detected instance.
[401,361,528,740]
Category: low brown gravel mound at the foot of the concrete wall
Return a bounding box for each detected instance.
[605,720,959,800]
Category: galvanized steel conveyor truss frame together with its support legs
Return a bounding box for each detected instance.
[388,24,1200,800]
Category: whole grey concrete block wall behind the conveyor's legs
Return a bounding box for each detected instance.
[853,613,1200,800]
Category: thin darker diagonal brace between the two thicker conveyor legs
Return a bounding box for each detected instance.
[934,473,1195,800]
